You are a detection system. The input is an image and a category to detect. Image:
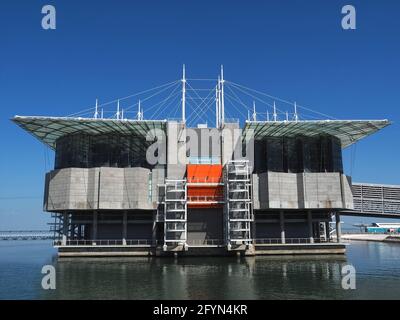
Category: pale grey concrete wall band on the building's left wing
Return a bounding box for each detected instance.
[44,167,156,211]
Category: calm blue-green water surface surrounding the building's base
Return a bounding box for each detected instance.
[0,241,400,299]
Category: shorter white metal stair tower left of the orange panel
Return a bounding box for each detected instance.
[163,179,187,251]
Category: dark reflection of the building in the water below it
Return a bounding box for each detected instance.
[41,255,346,299]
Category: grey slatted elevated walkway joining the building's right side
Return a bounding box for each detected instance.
[341,183,400,219]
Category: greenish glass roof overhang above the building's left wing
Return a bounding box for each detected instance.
[11,116,167,149]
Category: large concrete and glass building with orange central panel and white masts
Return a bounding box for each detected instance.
[12,69,389,256]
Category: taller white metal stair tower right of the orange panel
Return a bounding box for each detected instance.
[224,160,254,250]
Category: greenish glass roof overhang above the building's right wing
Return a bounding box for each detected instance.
[243,120,391,148]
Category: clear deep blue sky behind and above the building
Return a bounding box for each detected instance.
[0,0,400,229]
